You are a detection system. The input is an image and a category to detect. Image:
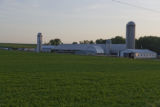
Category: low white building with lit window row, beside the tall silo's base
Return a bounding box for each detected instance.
[120,49,157,59]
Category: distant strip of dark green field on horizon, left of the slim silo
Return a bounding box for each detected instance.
[0,43,36,48]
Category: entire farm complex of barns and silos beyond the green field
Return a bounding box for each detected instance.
[37,21,157,58]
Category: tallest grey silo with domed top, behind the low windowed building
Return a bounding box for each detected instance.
[126,21,136,49]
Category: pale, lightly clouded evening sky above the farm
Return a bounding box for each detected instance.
[0,0,160,43]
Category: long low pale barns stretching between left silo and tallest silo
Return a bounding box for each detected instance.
[42,44,126,55]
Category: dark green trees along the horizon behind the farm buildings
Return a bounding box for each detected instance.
[47,36,160,54]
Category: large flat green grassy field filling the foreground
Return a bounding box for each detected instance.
[0,51,160,107]
